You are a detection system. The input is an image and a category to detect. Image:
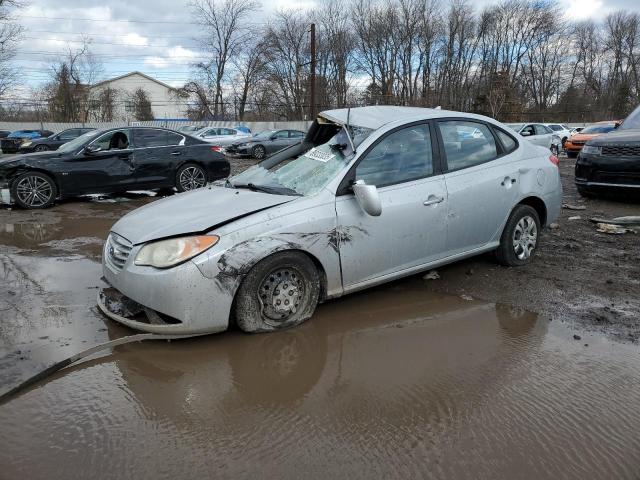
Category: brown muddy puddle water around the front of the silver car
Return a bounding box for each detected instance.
[0,199,640,479]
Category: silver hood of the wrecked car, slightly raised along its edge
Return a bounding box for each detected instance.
[111,186,298,245]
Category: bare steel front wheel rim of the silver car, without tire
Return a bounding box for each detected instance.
[258,267,304,326]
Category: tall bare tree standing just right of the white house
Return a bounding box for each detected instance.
[190,0,260,116]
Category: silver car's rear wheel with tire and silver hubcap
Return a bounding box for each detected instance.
[496,205,540,267]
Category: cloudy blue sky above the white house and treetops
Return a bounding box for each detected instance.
[8,0,640,95]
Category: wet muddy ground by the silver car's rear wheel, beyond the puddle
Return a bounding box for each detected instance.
[429,157,640,342]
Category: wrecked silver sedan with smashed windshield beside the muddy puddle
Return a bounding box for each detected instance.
[98,106,562,334]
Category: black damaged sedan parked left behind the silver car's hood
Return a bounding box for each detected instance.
[0,127,230,208]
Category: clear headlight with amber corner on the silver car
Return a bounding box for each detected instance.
[134,235,220,268]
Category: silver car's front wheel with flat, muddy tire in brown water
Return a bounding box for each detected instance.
[234,251,320,333]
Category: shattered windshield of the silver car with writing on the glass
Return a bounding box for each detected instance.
[229,127,372,195]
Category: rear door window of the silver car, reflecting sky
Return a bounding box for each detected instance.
[438,120,498,172]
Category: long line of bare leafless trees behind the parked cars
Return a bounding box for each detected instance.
[0,0,640,122]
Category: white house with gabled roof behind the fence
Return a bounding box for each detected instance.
[89,72,186,121]
